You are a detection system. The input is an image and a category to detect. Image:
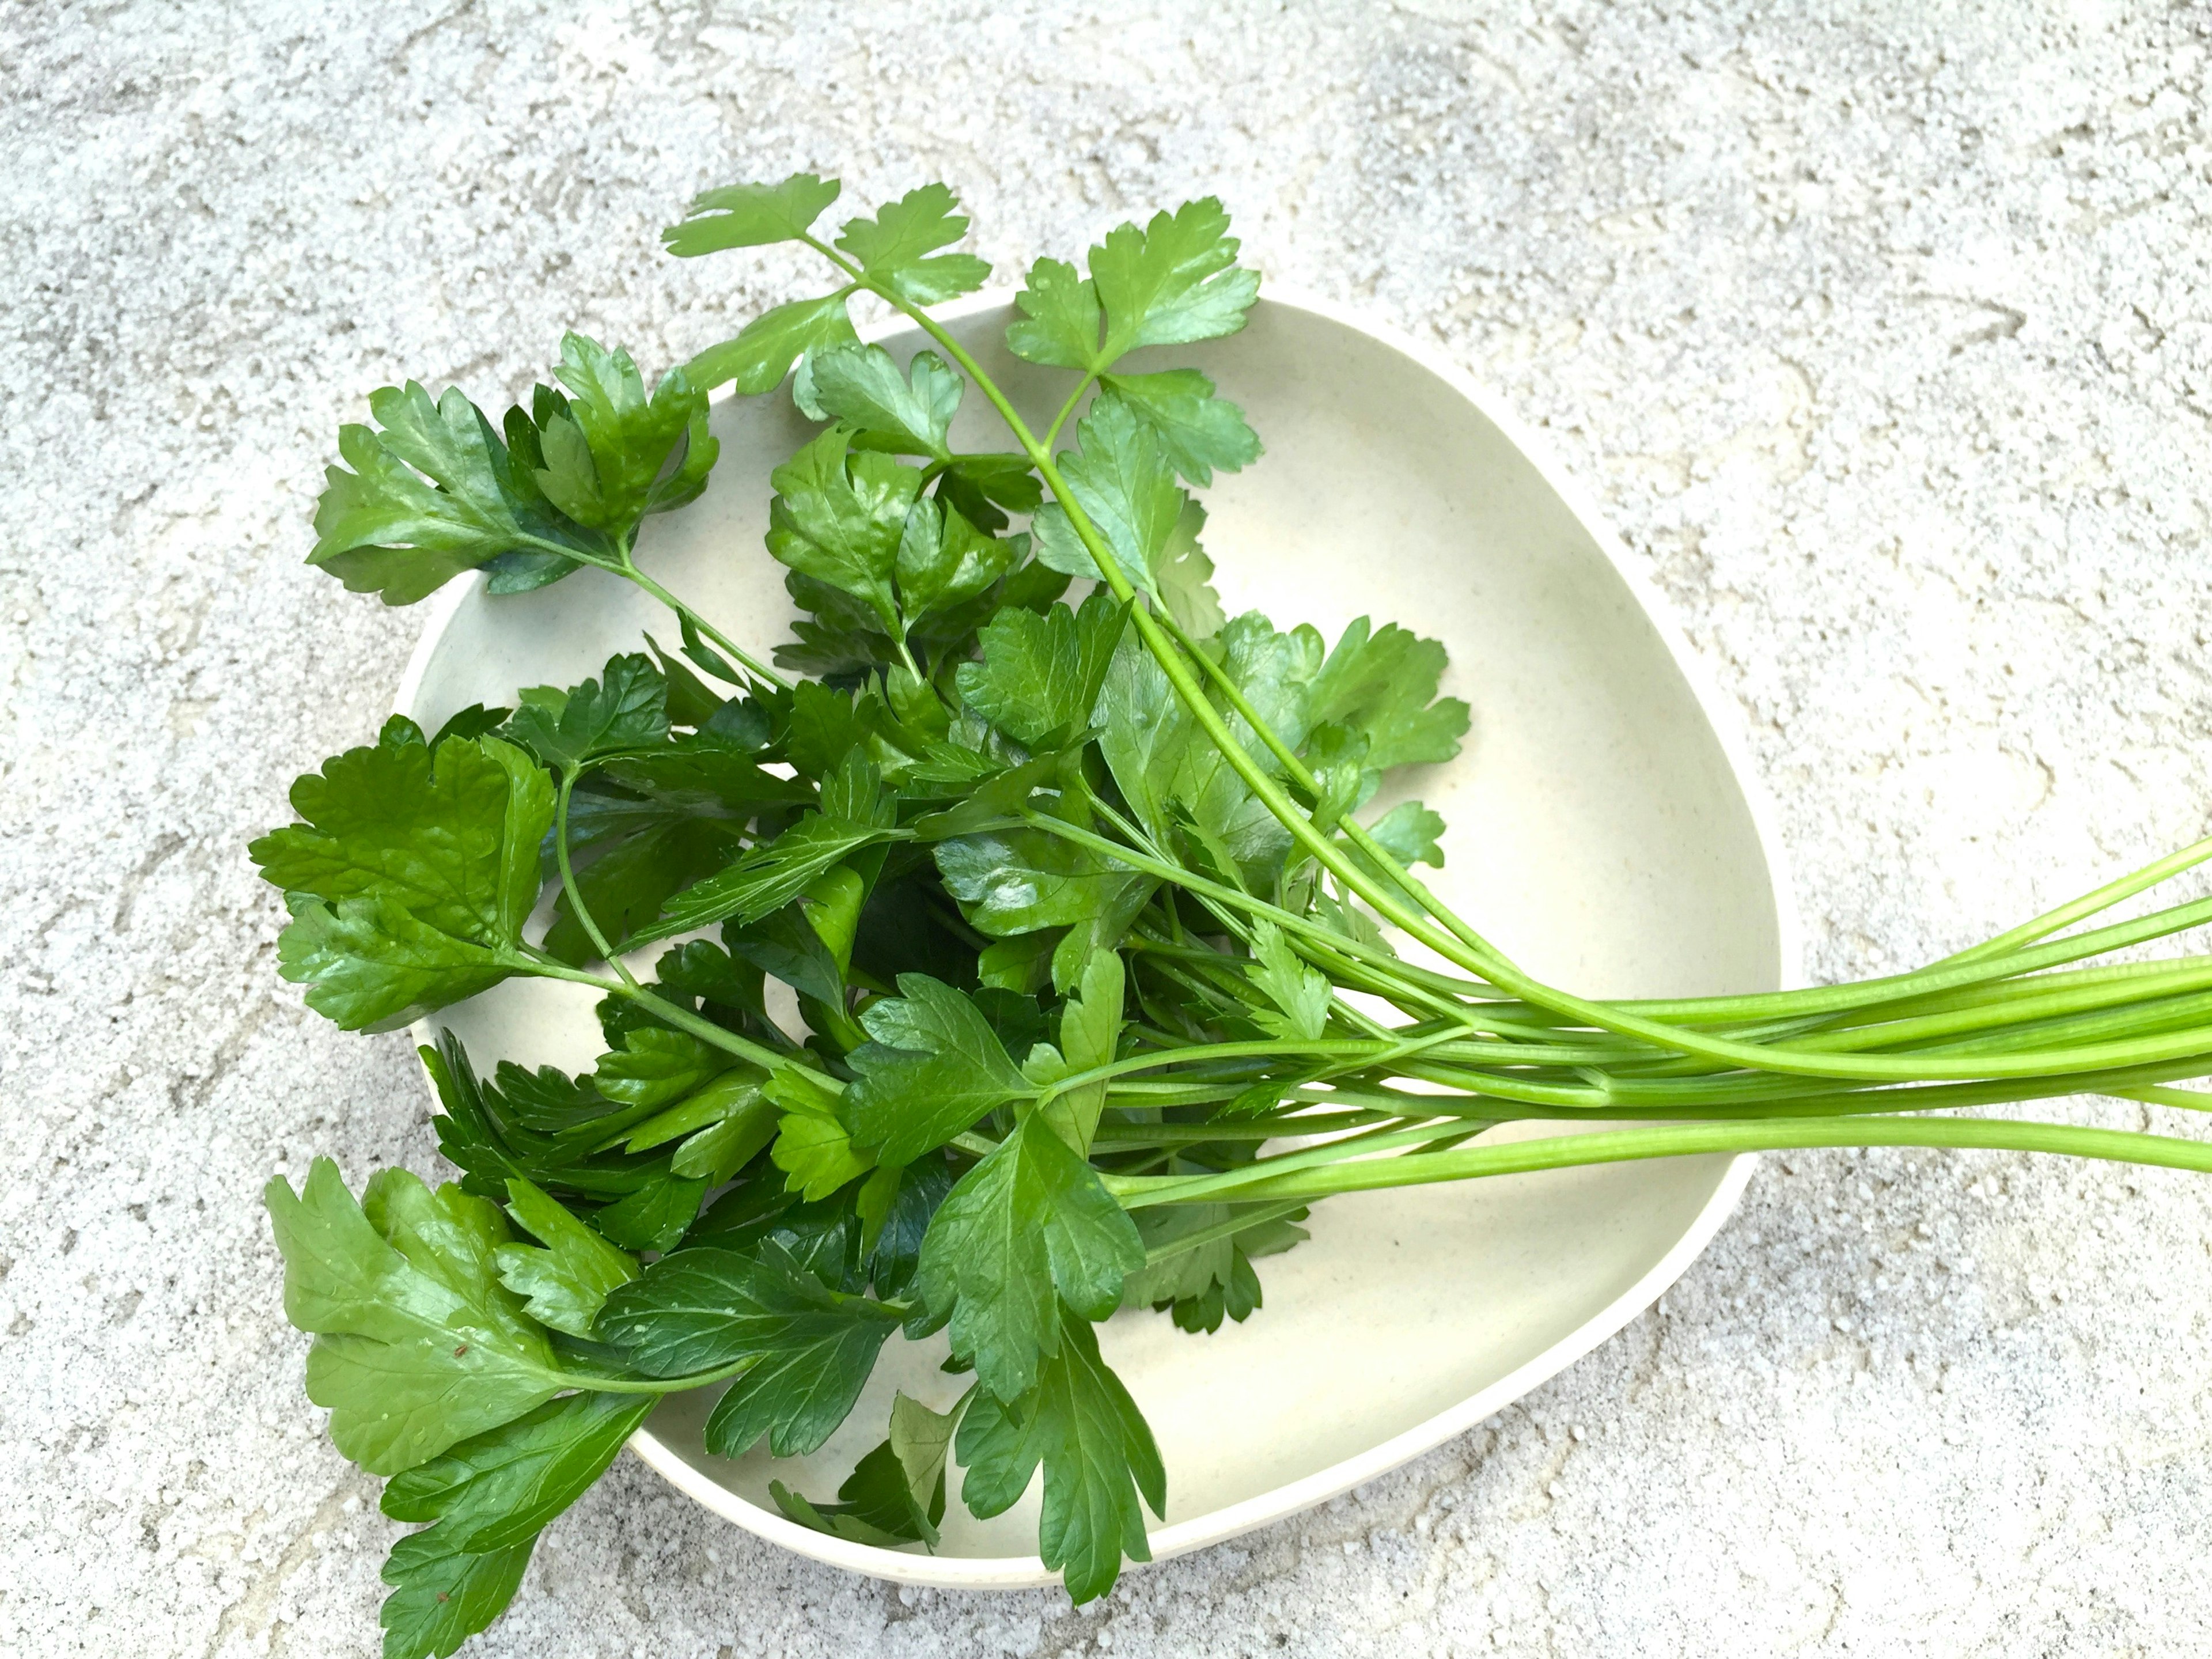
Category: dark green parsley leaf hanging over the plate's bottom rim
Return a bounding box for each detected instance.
[956,1309,1168,1604]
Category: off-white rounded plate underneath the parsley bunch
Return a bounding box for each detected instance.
[398,290,1798,1588]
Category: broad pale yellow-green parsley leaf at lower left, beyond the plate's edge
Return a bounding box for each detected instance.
[263,1157,564,1475]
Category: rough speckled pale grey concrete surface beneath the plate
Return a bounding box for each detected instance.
[0,0,2212,1659]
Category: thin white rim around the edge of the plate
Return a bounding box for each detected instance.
[394,281,1805,1590]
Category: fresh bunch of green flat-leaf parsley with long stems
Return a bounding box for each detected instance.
[252,175,2212,1659]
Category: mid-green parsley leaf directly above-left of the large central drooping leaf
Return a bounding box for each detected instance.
[845,974,1033,1164]
